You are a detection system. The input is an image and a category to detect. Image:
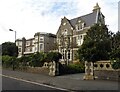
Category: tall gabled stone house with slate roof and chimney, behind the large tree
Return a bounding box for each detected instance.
[56,3,105,64]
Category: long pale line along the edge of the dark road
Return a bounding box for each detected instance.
[0,74,69,91]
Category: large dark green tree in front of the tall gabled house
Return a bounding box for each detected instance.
[78,24,111,62]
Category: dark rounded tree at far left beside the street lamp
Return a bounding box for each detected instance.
[2,42,18,56]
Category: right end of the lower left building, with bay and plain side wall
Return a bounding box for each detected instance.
[34,32,56,52]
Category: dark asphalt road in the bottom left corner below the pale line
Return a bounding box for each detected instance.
[2,76,67,92]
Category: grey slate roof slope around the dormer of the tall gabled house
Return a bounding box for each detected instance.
[69,11,97,27]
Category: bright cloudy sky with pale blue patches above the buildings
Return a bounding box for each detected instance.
[0,0,119,44]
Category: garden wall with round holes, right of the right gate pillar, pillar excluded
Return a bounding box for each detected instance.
[94,61,120,81]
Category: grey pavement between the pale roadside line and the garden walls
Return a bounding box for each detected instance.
[2,70,120,92]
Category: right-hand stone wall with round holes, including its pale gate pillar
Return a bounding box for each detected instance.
[84,60,120,81]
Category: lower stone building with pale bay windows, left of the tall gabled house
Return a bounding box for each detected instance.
[16,32,56,57]
